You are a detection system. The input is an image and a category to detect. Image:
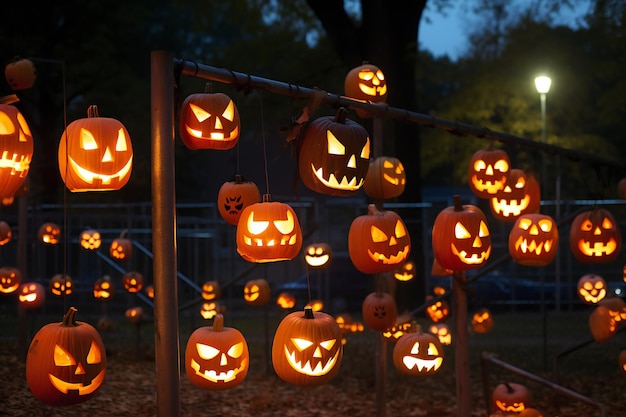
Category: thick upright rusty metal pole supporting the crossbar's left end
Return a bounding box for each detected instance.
[150,51,180,417]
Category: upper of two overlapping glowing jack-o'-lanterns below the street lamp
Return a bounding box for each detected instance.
[467,147,511,199]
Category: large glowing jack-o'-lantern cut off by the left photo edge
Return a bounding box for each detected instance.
[0,104,34,198]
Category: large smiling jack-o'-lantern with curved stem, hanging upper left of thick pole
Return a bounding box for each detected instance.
[58,106,133,192]
